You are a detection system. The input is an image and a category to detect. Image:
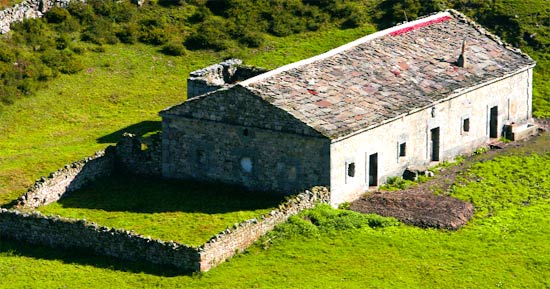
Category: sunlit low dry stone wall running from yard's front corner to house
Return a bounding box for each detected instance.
[199,187,330,271]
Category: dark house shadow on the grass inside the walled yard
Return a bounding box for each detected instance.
[58,175,283,214]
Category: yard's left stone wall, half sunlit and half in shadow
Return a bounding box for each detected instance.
[17,147,115,208]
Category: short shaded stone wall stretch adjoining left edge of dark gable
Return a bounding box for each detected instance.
[116,133,162,176]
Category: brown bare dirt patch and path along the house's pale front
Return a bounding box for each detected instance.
[350,119,550,230]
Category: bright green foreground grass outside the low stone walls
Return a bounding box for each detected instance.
[0,134,550,288]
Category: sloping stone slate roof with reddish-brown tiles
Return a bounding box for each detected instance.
[239,10,535,139]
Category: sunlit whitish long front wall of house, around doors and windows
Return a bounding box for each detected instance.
[330,69,532,205]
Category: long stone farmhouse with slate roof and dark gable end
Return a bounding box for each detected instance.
[160,10,535,205]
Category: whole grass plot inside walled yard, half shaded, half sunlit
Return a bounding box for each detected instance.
[39,176,283,246]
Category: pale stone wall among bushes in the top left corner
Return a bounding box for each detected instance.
[0,0,76,34]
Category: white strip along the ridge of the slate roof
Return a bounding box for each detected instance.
[237,10,452,86]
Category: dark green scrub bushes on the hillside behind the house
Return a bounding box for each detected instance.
[0,0,550,116]
